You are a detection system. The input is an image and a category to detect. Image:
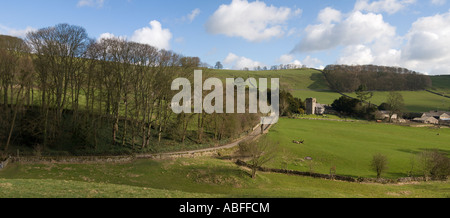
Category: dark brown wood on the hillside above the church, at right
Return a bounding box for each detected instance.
[323,65,431,92]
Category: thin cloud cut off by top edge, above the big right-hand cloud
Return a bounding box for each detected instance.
[355,0,416,14]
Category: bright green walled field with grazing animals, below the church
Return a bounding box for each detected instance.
[269,119,450,178]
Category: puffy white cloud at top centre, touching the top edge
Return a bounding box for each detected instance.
[205,0,294,42]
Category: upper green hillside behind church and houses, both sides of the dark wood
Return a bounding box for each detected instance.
[204,69,450,112]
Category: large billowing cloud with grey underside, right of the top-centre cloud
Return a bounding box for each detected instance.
[293,8,396,52]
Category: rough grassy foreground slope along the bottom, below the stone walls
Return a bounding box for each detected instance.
[0,158,450,198]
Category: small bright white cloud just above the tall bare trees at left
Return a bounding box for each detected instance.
[131,20,172,49]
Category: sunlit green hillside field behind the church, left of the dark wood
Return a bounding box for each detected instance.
[204,69,340,104]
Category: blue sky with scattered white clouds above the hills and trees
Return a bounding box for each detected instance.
[0,0,450,75]
